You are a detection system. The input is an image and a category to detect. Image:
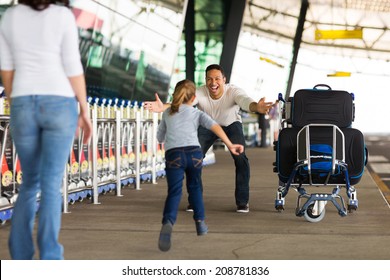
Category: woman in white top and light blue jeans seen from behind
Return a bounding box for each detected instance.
[0,0,92,259]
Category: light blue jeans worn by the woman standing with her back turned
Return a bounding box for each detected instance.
[9,95,78,259]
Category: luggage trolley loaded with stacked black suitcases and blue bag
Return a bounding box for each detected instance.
[274,85,368,222]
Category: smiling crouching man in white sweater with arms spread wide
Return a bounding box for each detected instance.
[145,64,274,213]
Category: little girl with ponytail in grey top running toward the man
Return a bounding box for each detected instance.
[157,80,244,251]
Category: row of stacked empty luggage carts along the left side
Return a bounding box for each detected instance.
[0,97,165,224]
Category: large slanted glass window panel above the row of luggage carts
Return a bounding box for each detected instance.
[72,0,184,101]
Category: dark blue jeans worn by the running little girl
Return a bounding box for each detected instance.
[162,147,205,225]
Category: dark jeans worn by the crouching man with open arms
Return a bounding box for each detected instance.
[198,122,250,206]
